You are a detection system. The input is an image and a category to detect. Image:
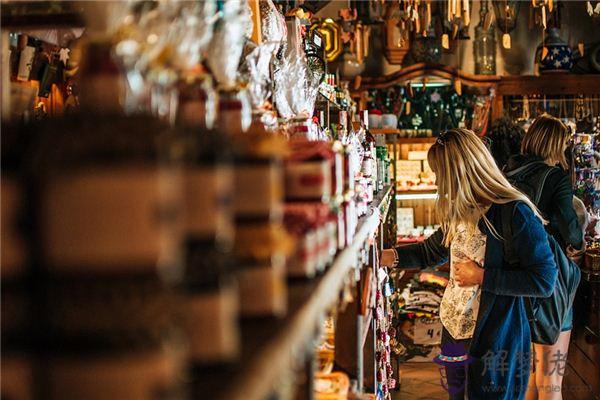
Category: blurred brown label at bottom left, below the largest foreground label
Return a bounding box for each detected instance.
[44,350,183,400]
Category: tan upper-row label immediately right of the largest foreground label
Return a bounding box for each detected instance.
[183,166,234,240]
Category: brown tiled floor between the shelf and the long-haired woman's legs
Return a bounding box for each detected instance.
[394,363,448,400]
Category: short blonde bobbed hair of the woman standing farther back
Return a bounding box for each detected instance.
[521,114,570,169]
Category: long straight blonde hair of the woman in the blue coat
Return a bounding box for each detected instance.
[427,129,543,246]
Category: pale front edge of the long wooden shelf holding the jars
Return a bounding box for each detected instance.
[222,186,392,400]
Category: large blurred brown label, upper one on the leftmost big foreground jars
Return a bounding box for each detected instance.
[40,167,182,273]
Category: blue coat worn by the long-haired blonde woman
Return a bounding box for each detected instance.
[396,203,557,400]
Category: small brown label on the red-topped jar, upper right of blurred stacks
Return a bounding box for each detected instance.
[285,160,331,201]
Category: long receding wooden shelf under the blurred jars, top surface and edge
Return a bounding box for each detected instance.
[194,186,392,400]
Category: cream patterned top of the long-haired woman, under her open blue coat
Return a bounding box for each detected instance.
[440,225,486,340]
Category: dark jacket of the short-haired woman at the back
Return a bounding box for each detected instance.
[504,154,583,250]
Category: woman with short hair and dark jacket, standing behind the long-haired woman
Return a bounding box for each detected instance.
[506,115,585,400]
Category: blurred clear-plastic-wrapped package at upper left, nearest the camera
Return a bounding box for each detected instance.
[109,0,217,115]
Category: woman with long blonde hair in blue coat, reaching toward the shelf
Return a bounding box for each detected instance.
[382,129,557,400]
